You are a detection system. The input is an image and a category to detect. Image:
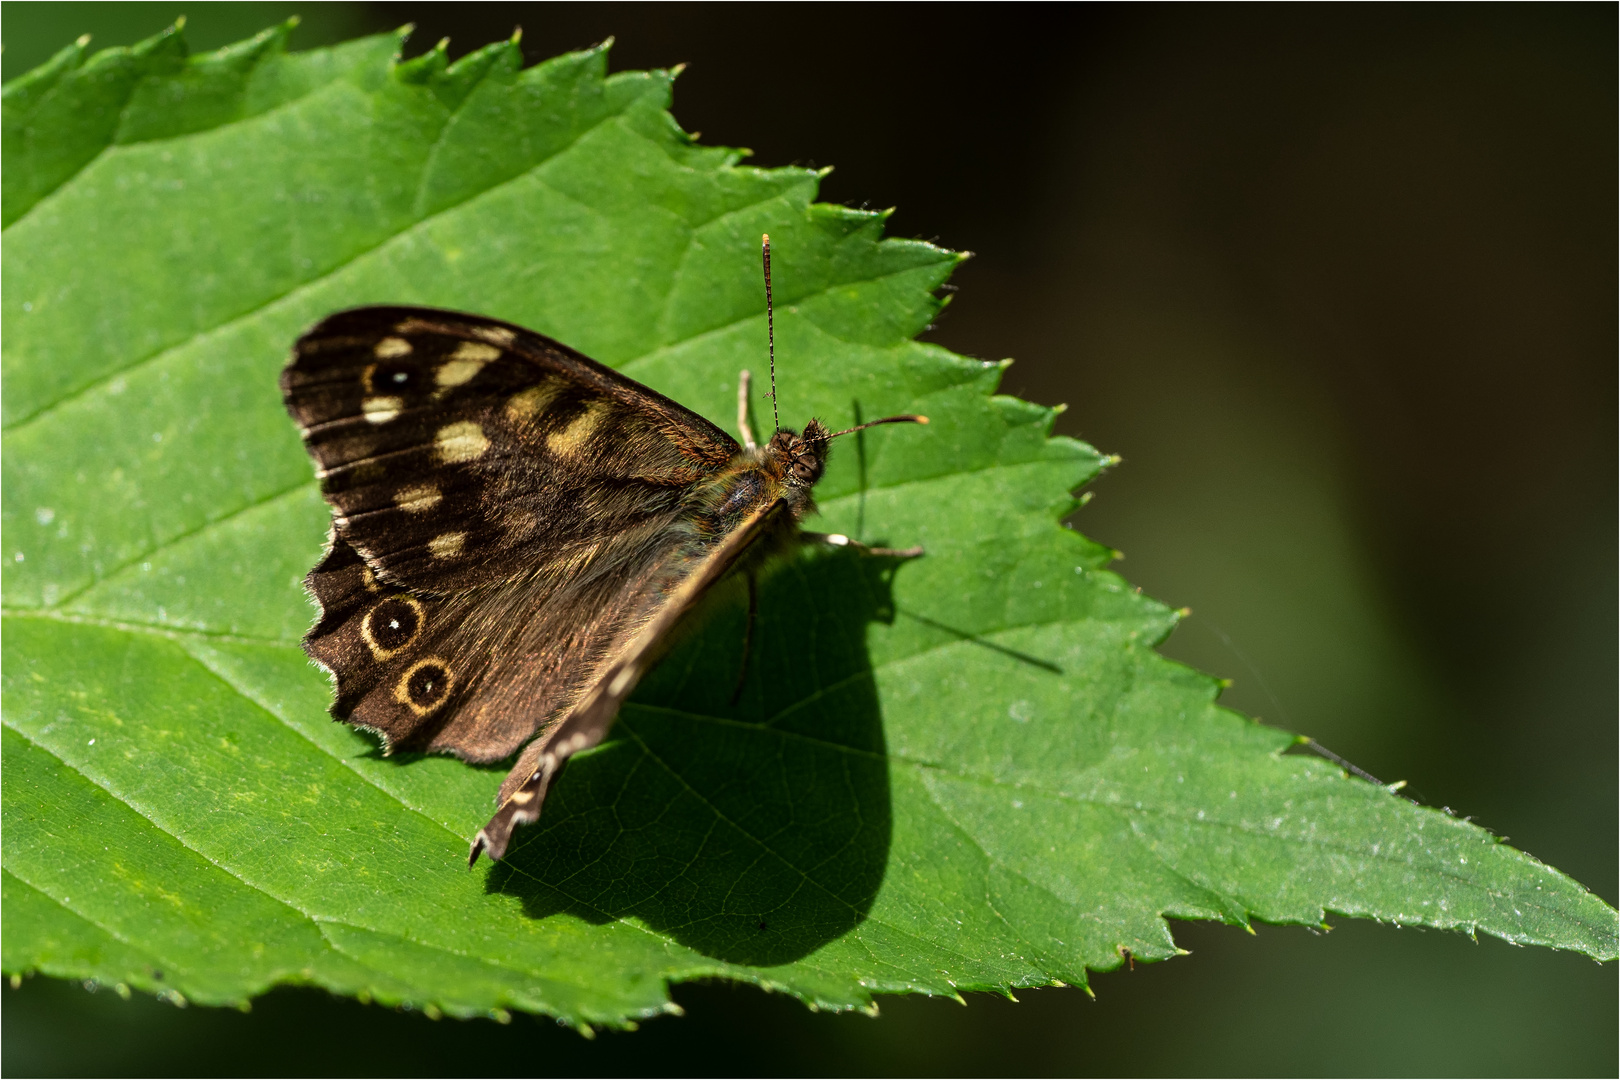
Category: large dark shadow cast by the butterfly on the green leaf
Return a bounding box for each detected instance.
[486,546,902,967]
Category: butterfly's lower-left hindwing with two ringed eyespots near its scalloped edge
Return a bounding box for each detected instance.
[305,529,701,763]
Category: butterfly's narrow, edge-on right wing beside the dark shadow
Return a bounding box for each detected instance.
[467,500,791,866]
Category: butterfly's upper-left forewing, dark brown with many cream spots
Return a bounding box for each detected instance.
[282,308,740,593]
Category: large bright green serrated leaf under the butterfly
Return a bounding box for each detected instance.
[0,28,1617,1025]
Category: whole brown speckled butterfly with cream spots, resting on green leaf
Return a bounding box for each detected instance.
[280,236,928,865]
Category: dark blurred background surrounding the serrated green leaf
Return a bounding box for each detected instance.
[0,3,1620,1075]
